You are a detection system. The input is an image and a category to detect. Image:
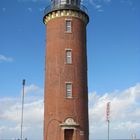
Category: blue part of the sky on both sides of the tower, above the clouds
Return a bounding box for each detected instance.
[0,0,140,94]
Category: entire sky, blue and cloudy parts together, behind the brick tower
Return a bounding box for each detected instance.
[0,0,140,140]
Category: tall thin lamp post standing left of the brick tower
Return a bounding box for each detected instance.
[20,79,25,140]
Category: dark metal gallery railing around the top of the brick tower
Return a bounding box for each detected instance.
[44,1,88,15]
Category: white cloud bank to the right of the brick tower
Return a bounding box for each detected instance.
[89,84,140,139]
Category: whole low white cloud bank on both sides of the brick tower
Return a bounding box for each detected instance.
[0,83,140,140]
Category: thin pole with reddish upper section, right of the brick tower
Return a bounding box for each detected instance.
[106,102,110,140]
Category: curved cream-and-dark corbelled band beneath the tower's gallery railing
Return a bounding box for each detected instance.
[44,10,89,24]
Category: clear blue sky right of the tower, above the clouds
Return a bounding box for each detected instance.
[88,0,140,93]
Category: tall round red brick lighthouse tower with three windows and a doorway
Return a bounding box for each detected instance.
[44,0,89,140]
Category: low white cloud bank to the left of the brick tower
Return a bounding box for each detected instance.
[0,98,44,140]
